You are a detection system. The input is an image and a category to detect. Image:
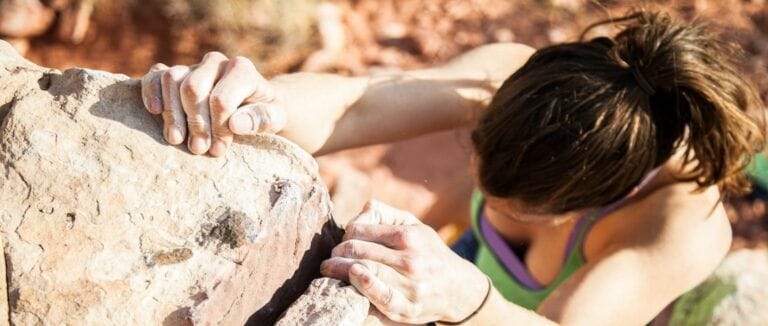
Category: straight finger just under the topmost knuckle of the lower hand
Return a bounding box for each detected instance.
[343,222,419,249]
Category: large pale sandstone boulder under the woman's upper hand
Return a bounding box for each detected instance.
[0,41,338,325]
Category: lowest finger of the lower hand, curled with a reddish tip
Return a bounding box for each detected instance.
[349,262,412,322]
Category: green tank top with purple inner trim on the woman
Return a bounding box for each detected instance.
[471,191,604,310]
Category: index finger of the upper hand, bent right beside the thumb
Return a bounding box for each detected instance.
[210,57,266,156]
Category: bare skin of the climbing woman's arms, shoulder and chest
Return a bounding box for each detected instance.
[142,44,731,325]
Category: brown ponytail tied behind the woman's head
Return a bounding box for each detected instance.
[608,12,763,192]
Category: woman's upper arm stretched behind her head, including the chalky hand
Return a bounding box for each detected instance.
[142,43,533,156]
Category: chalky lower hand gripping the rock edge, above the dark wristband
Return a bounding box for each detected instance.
[321,202,489,324]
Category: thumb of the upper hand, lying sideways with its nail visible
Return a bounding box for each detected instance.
[229,103,287,135]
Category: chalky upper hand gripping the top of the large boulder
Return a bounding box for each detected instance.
[141,52,286,156]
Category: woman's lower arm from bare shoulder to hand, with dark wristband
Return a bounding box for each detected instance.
[322,186,731,325]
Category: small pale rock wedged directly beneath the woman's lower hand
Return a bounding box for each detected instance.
[277,277,370,326]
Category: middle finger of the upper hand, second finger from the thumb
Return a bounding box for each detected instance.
[181,52,227,155]
